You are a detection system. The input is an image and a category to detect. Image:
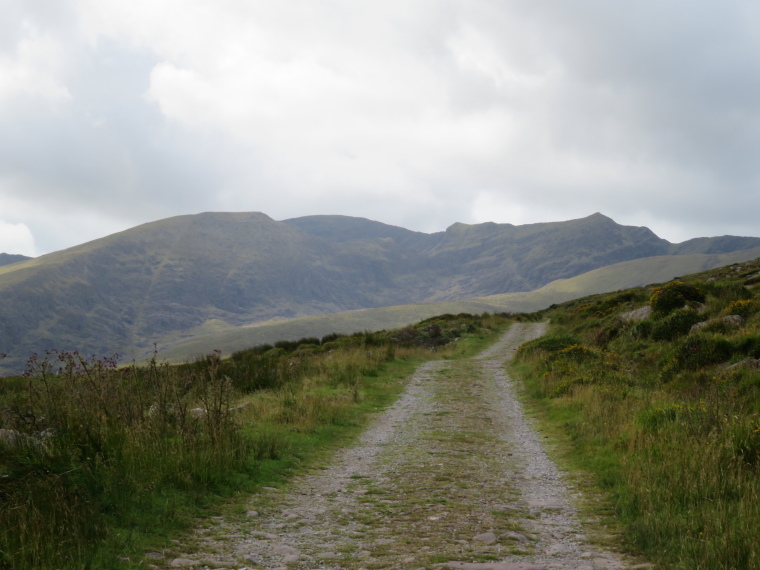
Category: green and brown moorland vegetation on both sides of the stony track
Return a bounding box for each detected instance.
[0,250,760,569]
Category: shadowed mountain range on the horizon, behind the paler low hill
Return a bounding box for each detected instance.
[0,209,760,371]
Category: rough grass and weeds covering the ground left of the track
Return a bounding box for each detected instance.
[0,314,524,569]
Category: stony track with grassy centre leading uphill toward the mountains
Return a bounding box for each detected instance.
[156,324,648,570]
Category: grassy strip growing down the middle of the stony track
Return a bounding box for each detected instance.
[332,346,530,567]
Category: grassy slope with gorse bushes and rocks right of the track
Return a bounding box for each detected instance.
[515,260,760,569]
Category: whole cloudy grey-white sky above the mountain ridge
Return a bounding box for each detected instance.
[0,0,760,256]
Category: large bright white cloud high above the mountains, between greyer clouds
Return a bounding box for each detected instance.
[78,1,528,203]
